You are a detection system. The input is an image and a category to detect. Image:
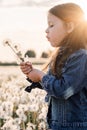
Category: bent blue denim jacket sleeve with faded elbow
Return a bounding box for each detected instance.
[41,50,87,99]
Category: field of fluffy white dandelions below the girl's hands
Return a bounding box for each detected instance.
[0,67,47,130]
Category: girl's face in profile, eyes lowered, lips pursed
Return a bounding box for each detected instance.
[46,13,67,47]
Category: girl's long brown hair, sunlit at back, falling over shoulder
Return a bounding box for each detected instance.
[46,3,87,78]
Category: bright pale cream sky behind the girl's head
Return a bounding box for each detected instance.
[0,0,87,62]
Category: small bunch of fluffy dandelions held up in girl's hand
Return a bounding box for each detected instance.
[3,39,25,64]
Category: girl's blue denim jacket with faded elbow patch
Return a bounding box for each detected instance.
[41,49,87,130]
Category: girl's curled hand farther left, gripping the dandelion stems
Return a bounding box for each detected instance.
[20,61,33,76]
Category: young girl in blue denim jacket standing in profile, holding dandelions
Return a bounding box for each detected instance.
[20,3,87,130]
